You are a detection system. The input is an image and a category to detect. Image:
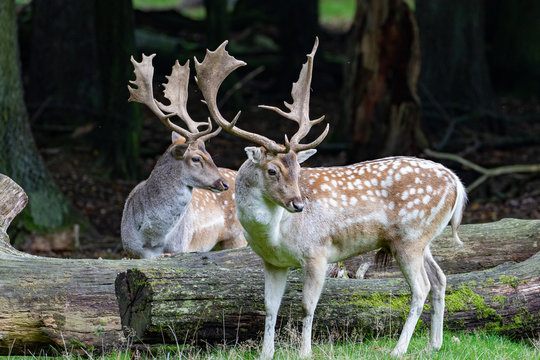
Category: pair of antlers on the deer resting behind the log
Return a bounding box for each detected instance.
[128,54,221,141]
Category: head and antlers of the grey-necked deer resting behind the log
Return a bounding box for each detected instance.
[128,54,229,192]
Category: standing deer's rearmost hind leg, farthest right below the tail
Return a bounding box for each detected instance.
[424,248,446,350]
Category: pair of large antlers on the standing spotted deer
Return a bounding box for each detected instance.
[195,38,329,153]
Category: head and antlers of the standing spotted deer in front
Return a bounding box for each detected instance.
[195,39,329,212]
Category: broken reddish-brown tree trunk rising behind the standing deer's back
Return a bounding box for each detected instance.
[344,0,425,162]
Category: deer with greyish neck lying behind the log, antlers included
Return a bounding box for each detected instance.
[121,54,247,258]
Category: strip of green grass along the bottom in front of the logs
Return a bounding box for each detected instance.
[3,331,540,360]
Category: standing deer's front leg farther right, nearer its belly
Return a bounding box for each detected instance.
[300,256,327,358]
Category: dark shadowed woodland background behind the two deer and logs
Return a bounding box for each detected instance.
[0,0,540,259]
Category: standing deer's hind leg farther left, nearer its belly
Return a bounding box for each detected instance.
[391,246,430,357]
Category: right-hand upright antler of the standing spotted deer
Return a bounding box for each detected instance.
[259,37,329,152]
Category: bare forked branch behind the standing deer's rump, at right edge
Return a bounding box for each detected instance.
[424,149,540,192]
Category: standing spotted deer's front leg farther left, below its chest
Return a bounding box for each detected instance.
[261,262,288,359]
